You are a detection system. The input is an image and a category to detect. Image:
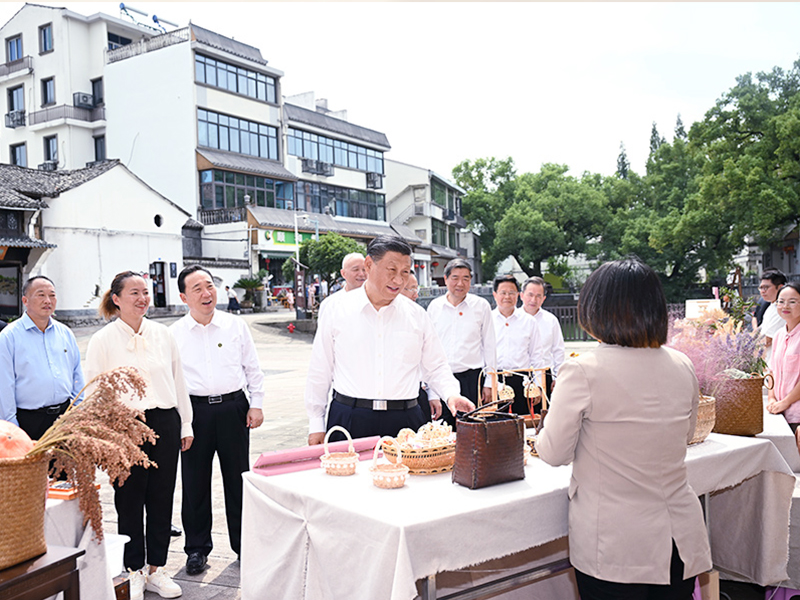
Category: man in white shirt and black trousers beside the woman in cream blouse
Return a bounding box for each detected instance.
[170,265,264,575]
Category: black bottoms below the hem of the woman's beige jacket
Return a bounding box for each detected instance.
[575,542,695,600]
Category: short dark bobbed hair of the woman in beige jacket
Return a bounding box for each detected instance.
[578,257,669,348]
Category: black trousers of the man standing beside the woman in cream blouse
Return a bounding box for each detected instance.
[181,390,250,556]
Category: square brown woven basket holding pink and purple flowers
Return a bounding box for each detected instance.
[712,374,772,435]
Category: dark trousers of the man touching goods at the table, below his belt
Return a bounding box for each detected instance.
[328,400,425,442]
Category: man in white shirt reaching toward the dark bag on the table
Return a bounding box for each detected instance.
[305,236,473,445]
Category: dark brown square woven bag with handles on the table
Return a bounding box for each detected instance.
[453,402,525,490]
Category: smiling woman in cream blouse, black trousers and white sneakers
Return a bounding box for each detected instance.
[85,271,193,600]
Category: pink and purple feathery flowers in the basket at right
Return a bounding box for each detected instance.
[667,309,766,396]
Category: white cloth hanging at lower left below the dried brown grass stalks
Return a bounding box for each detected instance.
[44,499,116,600]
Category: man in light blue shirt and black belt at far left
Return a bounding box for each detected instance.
[0,276,83,440]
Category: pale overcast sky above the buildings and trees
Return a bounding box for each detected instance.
[0,1,800,176]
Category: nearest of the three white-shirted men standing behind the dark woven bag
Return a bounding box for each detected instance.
[428,258,495,421]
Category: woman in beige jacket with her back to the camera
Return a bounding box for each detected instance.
[536,259,711,600]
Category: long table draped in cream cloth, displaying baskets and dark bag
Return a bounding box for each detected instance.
[241,434,794,600]
